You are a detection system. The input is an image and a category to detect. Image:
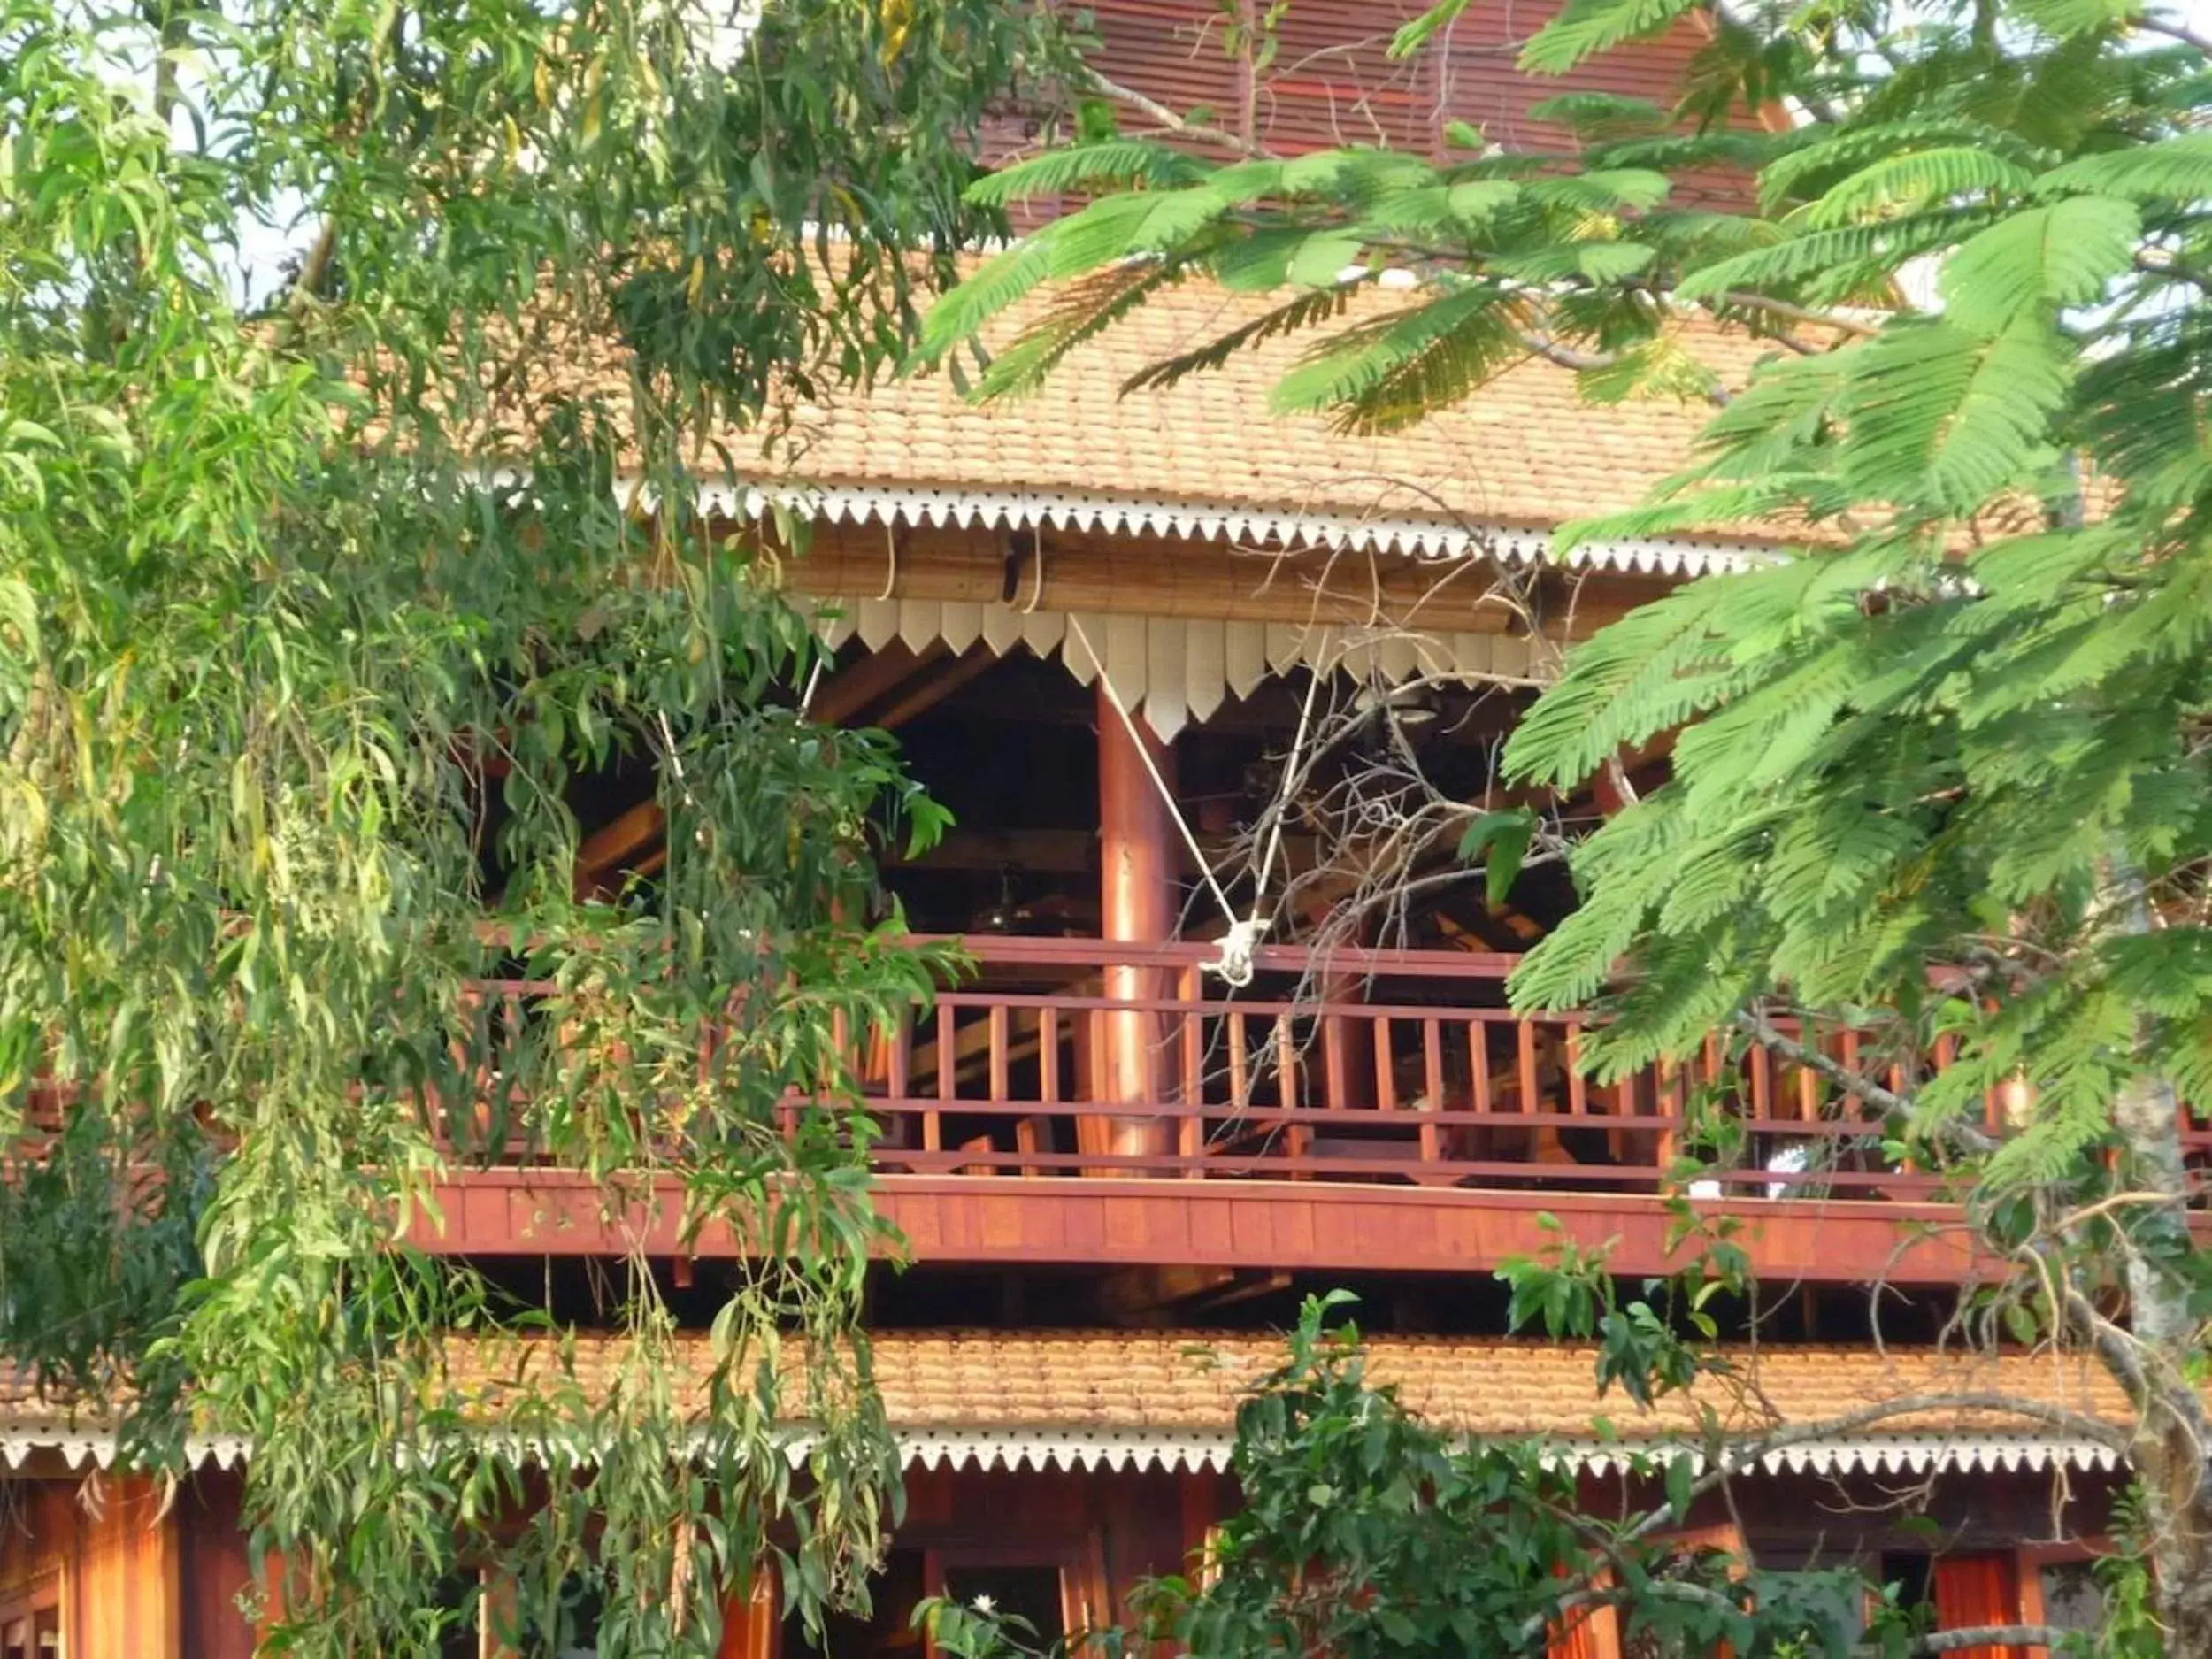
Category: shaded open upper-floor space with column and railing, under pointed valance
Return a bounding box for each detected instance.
[435,637,1991,1199]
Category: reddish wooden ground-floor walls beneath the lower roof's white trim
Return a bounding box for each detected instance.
[0,1460,2110,1659]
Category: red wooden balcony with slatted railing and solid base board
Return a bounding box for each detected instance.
[423,938,1998,1283]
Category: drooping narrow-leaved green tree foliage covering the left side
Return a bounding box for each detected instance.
[0,0,1062,1655]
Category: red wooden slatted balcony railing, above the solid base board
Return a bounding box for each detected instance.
[453,936,2212,1202]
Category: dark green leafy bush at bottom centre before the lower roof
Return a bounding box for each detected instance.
[920,1294,1867,1659]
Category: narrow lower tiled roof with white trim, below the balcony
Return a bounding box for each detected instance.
[0,1332,2128,1473]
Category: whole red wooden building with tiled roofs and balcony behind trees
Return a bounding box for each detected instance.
[0,0,2150,1659]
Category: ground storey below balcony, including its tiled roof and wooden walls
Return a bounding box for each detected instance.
[0,1327,2126,1659]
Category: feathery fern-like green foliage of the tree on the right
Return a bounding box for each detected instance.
[932,0,2212,1646]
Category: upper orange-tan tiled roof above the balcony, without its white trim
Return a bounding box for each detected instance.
[535,281,1781,555]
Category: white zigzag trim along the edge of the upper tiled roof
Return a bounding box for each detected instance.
[681,480,1778,578]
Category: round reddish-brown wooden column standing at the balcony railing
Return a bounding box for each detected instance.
[1082,695,1175,1157]
